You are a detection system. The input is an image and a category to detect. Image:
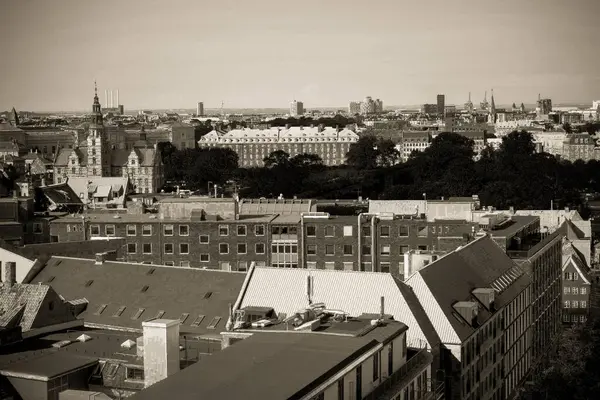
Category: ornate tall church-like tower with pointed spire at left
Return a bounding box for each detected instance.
[87,81,110,177]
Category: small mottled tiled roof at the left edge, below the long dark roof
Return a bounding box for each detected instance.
[0,283,50,332]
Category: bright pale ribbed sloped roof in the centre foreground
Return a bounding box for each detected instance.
[239,267,431,347]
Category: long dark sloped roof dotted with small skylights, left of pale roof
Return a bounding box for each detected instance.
[33,257,246,334]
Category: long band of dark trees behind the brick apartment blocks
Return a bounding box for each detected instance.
[161,131,600,209]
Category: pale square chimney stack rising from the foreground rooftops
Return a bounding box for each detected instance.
[142,319,180,387]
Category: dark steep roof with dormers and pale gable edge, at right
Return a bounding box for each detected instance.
[406,236,531,342]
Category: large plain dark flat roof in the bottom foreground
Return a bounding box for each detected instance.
[131,323,405,400]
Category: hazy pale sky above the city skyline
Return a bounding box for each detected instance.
[0,0,600,111]
